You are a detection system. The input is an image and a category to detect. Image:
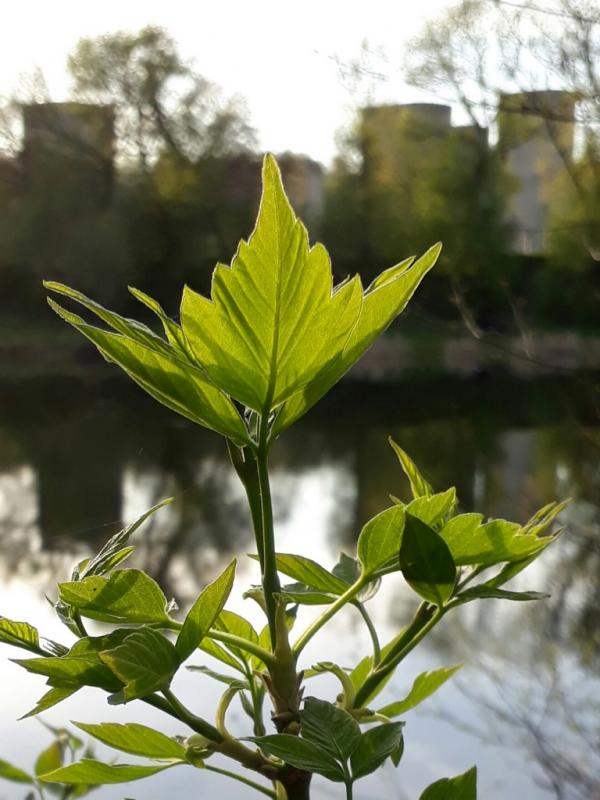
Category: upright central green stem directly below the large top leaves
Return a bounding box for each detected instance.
[256,413,281,650]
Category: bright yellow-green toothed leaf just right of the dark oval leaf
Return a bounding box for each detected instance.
[439,514,554,567]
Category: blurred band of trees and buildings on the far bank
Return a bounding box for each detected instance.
[0,14,600,331]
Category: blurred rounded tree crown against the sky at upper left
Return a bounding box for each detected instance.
[68,26,255,170]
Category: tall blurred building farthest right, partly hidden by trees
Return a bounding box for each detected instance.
[498,91,576,255]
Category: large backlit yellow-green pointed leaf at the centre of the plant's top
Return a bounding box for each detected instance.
[181,155,362,413]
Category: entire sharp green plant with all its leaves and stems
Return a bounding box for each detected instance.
[0,156,562,800]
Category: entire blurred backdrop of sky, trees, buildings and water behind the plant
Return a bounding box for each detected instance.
[0,0,600,800]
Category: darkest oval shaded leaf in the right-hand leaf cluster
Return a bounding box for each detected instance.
[400,513,456,607]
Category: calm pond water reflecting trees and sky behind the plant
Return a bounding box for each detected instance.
[0,373,600,800]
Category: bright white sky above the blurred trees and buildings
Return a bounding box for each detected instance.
[0,0,450,163]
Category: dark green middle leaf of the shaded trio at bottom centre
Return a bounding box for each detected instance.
[300,697,360,761]
